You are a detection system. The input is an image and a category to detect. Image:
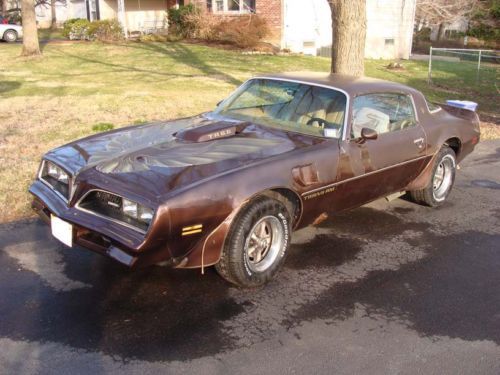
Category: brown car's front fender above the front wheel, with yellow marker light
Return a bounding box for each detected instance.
[160,144,338,268]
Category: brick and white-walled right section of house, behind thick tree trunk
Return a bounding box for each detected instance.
[194,0,417,59]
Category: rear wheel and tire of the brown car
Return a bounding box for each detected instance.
[409,145,457,207]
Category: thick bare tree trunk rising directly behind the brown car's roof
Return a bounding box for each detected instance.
[329,0,366,76]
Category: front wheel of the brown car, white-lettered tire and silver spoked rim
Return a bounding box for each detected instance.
[215,196,291,288]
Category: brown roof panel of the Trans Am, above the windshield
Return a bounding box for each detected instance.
[256,72,418,96]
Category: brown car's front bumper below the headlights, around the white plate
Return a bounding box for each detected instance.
[29,180,174,267]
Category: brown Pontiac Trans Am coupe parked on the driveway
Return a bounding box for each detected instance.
[30,73,479,287]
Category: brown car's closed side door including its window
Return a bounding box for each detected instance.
[335,93,427,213]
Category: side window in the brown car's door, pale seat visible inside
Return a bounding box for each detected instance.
[351,93,417,138]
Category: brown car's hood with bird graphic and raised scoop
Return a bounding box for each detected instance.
[45,115,322,203]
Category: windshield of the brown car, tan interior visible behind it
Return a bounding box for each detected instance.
[215,78,347,138]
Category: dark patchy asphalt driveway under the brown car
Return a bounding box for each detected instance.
[0,141,500,375]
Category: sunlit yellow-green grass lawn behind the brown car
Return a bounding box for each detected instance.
[0,42,499,222]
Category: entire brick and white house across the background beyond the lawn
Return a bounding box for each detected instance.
[6,0,417,59]
